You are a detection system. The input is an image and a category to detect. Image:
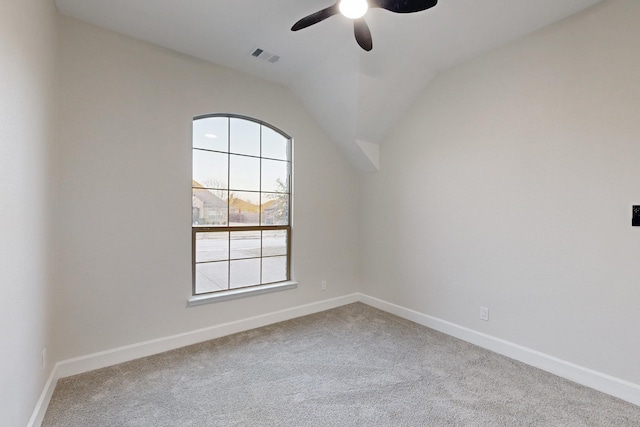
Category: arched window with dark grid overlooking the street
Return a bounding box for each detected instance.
[192,114,292,296]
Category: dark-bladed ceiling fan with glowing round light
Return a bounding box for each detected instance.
[291,0,438,51]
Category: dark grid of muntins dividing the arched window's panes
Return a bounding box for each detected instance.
[192,114,292,295]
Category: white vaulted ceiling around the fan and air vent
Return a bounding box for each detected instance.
[56,0,600,172]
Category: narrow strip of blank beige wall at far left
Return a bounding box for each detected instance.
[0,0,57,426]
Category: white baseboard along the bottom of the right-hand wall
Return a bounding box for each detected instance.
[359,294,640,406]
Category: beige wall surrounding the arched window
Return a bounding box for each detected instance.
[55,17,359,360]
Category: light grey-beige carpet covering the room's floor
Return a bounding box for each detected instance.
[42,303,640,427]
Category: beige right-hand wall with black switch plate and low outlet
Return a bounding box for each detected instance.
[361,0,640,384]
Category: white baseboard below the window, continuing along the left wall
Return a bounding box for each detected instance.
[27,294,359,427]
